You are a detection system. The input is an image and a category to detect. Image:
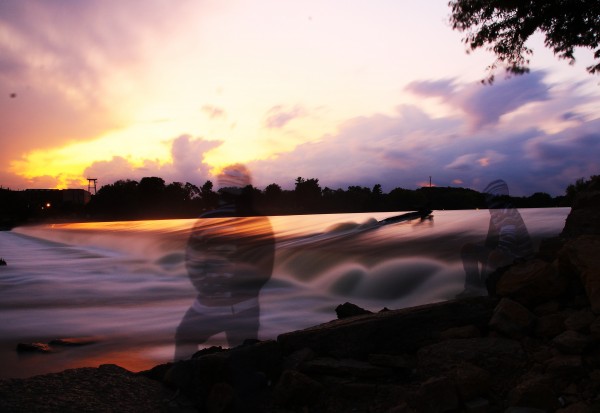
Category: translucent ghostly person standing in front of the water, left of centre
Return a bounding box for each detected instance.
[175,165,275,360]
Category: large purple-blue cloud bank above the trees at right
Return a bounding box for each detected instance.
[250,72,600,195]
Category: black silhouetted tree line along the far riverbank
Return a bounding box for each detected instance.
[0,176,600,228]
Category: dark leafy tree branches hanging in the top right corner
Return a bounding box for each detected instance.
[449,0,600,82]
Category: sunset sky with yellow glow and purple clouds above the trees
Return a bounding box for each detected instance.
[0,0,600,195]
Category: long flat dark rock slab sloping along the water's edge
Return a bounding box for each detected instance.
[277,297,497,359]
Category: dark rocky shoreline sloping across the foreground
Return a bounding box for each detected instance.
[0,191,600,413]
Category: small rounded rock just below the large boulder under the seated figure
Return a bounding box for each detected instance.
[490,298,536,337]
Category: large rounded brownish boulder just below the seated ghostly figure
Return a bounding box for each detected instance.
[496,259,568,305]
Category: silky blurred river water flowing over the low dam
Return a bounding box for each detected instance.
[0,208,569,377]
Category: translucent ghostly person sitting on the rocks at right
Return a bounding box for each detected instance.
[459,179,533,297]
